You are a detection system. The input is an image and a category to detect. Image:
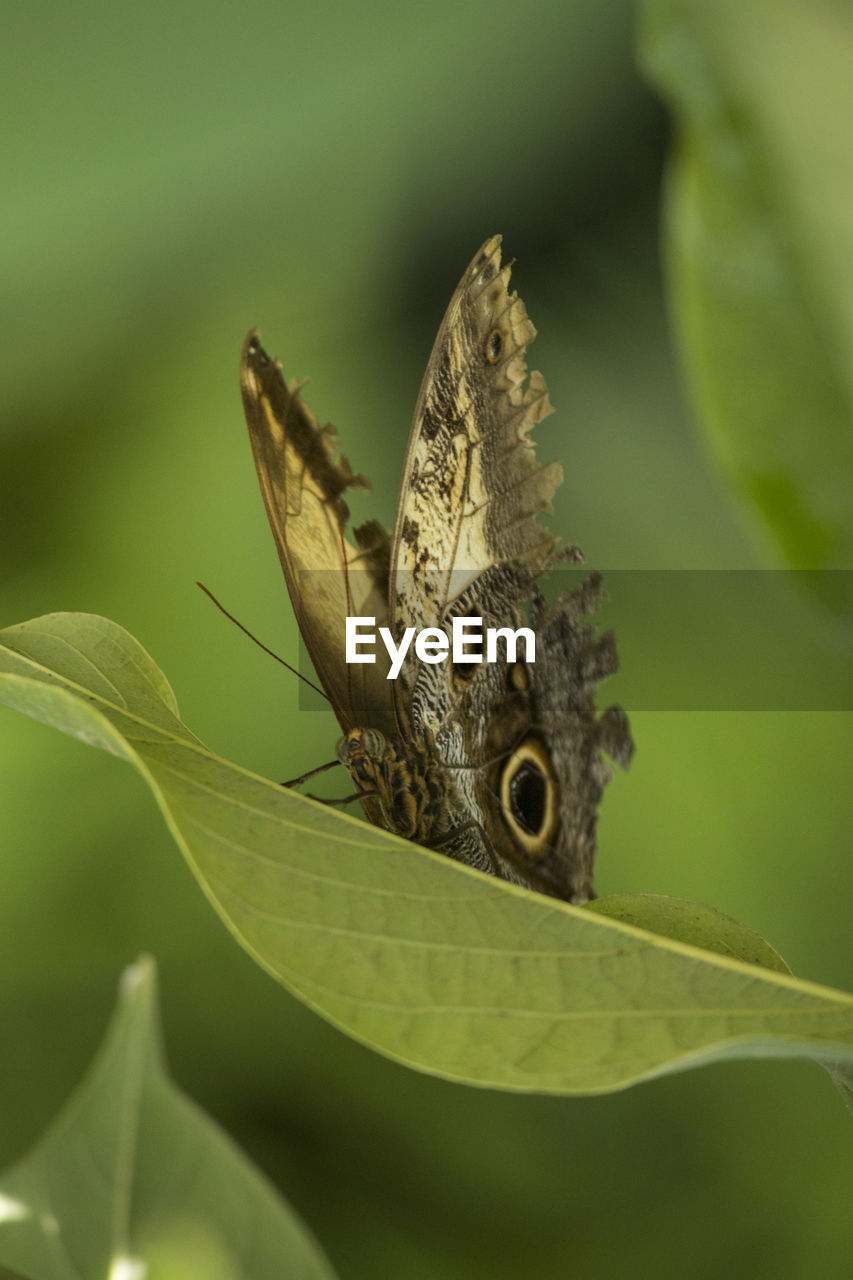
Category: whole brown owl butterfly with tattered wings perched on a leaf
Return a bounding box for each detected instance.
[241,236,633,902]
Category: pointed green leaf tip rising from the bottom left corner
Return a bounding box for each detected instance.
[0,960,333,1280]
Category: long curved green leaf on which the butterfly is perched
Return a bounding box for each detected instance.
[0,614,853,1093]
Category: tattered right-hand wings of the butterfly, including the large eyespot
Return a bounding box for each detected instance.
[391,237,631,902]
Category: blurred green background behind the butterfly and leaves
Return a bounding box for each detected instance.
[0,0,853,1280]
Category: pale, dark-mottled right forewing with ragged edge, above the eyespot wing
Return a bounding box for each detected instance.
[391,236,562,630]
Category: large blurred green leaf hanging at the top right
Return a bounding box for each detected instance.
[642,0,853,596]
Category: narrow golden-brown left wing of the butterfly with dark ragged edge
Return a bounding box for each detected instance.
[240,330,394,732]
